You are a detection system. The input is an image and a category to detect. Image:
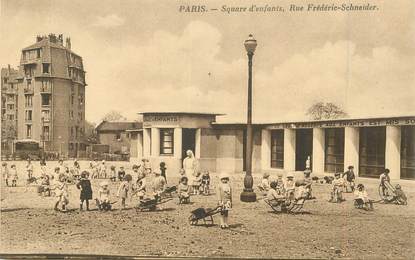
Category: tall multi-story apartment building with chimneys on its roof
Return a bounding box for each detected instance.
[2,34,86,157]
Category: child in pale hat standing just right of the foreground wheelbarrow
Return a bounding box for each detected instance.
[217,173,232,229]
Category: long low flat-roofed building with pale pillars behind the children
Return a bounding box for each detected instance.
[131,113,415,180]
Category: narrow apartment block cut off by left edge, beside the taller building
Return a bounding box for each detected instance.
[1,65,21,154]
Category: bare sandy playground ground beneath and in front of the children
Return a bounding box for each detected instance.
[0,162,415,259]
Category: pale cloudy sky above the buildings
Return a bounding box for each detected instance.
[0,0,415,122]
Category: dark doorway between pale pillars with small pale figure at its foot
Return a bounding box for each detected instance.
[295,129,313,171]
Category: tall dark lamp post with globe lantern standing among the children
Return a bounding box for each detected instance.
[241,34,257,202]
